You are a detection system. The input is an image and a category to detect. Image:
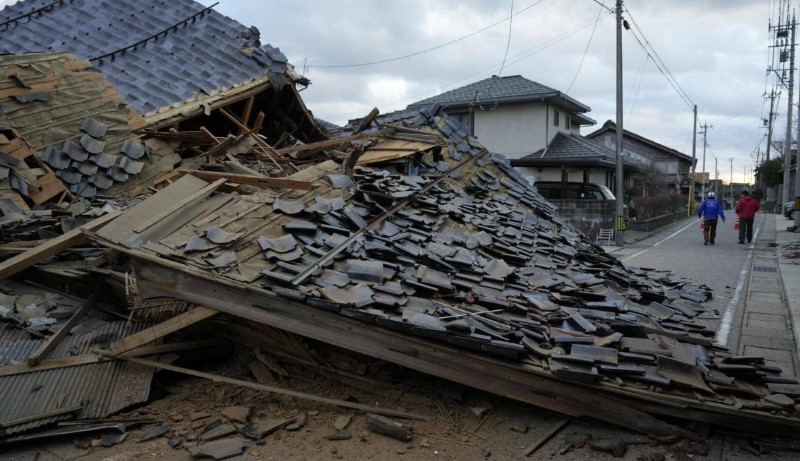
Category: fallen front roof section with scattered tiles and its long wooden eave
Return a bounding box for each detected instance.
[0,104,800,437]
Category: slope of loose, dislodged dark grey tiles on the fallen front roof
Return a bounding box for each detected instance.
[98,108,800,438]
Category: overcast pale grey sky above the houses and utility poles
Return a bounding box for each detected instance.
[198,0,780,182]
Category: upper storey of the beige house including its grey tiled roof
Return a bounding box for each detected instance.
[408,75,595,159]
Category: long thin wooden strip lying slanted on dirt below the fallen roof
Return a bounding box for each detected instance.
[113,357,428,421]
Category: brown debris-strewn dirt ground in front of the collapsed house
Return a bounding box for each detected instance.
[0,349,796,461]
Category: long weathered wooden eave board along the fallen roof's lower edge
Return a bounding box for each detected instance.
[121,255,700,437]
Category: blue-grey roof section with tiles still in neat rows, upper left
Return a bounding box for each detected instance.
[0,0,287,114]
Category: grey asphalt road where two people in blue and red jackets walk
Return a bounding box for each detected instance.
[613,210,763,345]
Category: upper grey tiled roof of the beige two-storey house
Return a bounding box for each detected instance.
[408,75,589,111]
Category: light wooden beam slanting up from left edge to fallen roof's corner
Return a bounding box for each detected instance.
[0,209,123,280]
